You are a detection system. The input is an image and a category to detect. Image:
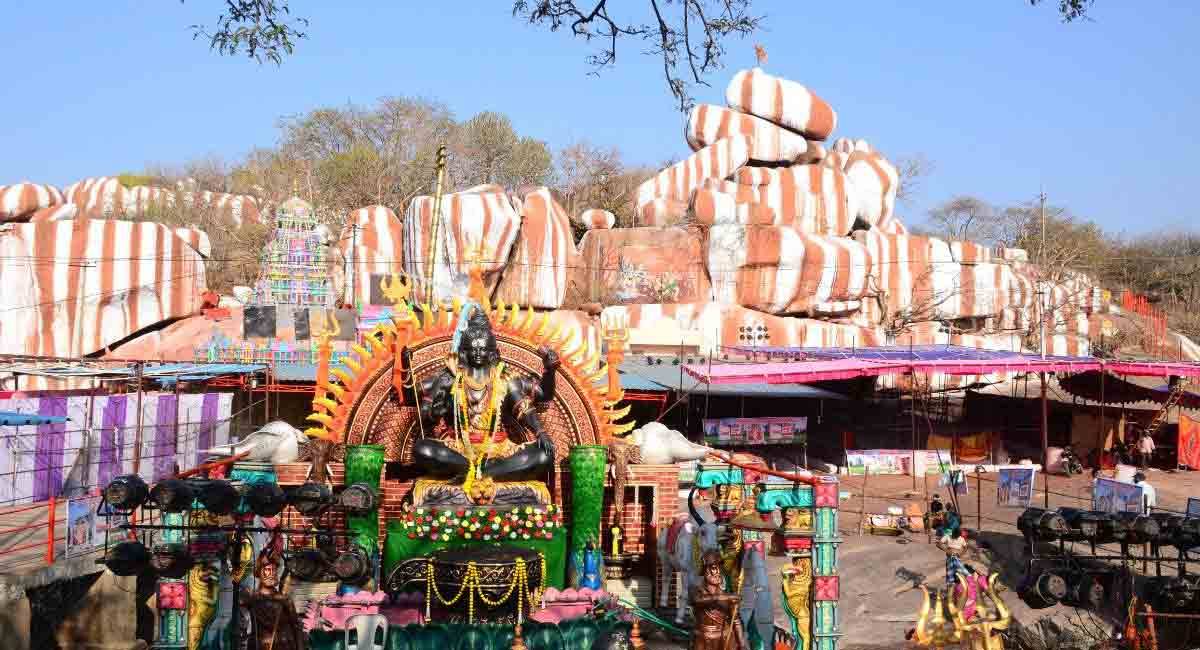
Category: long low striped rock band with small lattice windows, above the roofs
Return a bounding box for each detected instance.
[600,302,883,355]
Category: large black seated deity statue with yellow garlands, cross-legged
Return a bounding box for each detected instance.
[406,303,560,494]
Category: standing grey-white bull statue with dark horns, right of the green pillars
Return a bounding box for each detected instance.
[659,488,718,624]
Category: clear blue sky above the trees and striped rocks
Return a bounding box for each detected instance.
[0,0,1200,233]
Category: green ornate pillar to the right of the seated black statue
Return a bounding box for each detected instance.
[566,445,608,589]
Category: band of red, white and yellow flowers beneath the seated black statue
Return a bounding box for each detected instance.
[400,505,563,542]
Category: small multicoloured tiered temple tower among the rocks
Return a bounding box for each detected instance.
[253,197,334,307]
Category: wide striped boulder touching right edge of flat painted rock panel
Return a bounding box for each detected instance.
[708,224,871,317]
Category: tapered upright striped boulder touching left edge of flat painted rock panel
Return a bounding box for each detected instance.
[496,187,578,309]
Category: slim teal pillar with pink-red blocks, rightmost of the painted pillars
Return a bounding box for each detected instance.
[812,476,841,650]
